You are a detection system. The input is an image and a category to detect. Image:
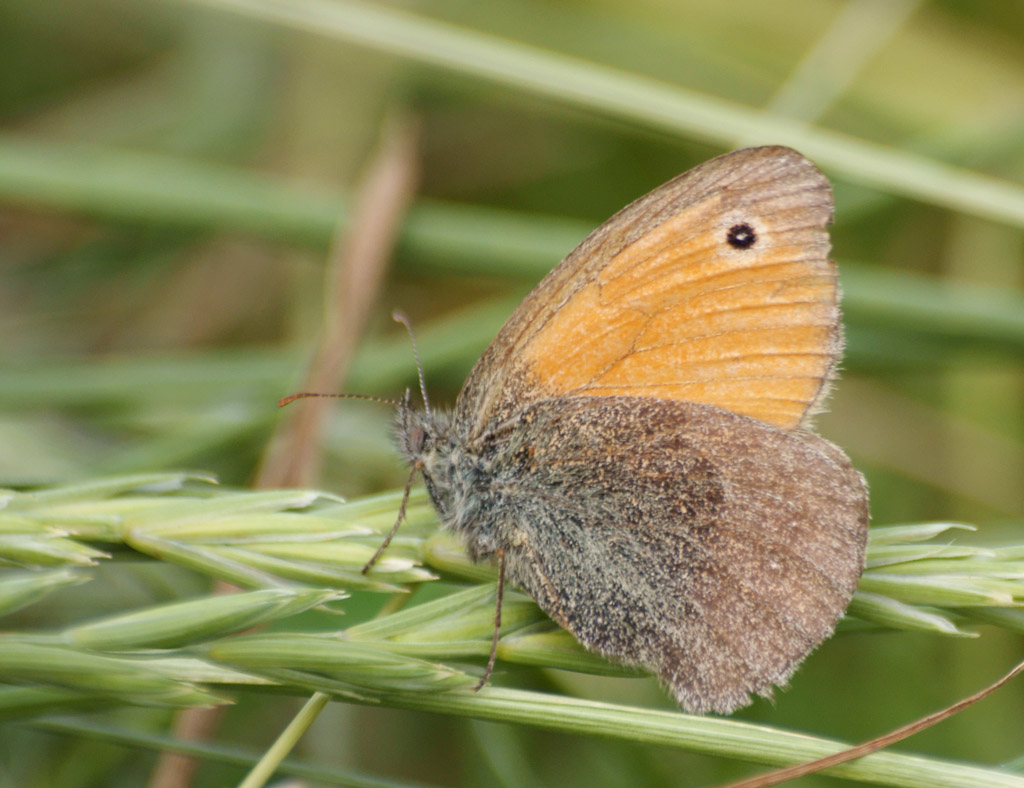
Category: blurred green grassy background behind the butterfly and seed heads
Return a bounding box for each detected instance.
[0,0,1024,788]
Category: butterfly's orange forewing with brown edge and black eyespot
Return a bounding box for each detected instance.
[460,147,842,429]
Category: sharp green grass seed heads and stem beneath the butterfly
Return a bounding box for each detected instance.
[0,474,1024,786]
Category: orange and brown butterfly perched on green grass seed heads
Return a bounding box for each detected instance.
[387,146,868,713]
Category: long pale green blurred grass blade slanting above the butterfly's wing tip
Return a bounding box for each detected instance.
[180,0,1024,226]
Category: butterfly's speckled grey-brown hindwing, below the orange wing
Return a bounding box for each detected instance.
[481,397,867,711]
